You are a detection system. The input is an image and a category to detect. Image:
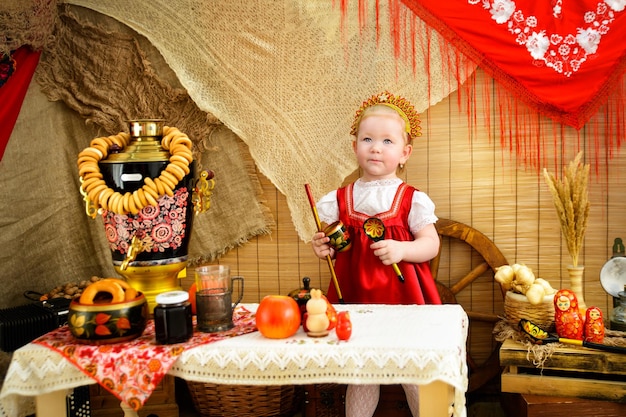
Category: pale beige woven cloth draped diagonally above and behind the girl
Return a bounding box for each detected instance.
[65,0,474,240]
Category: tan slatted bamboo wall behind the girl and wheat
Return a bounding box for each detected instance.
[186,69,626,364]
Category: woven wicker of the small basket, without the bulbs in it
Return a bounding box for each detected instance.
[504,291,554,332]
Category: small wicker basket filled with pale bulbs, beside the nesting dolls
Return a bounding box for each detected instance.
[494,264,556,331]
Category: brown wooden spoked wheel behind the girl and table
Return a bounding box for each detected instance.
[430,219,508,392]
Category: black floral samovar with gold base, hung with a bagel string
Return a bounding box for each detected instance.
[78,119,215,312]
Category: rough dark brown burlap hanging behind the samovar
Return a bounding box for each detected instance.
[0,4,274,306]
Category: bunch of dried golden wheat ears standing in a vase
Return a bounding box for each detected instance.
[543,152,589,266]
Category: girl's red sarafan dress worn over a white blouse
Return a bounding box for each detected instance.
[327,182,441,304]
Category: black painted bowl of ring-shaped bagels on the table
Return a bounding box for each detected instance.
[67,278,148,344]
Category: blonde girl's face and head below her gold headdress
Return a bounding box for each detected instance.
[353,111,413,181]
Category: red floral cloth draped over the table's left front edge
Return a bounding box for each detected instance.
[33,306,256,410]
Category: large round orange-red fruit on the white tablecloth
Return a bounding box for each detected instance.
[256,295,301,339]
